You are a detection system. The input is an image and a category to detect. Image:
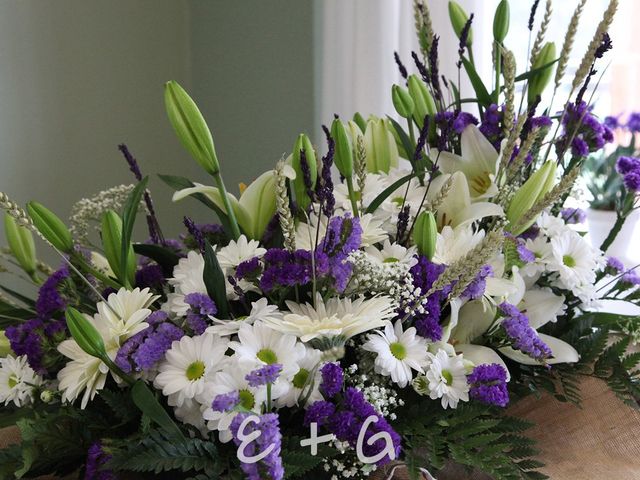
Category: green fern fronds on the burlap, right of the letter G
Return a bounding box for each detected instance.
[397,397,546,480]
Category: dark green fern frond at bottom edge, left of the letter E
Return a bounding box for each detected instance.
[107,431,222,478]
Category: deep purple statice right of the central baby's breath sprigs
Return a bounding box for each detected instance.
[409,255,451,342]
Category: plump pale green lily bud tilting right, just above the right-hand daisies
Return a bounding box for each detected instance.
[507,160,557,235]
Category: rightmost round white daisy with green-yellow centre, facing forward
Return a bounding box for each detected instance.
[547,230,598,289]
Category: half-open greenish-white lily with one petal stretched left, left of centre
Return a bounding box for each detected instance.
[173,170,276,240]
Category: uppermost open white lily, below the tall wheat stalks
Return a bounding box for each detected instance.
[438,125,499,200]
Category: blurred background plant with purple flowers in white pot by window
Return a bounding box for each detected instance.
[583,113,640,263]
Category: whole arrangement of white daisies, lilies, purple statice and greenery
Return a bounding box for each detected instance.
[0,0,640,480]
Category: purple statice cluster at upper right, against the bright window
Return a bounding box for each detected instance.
[556,100,613,157]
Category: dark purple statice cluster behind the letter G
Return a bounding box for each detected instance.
[304,387,401,466]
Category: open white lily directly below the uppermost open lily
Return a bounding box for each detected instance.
[429,172,504,230]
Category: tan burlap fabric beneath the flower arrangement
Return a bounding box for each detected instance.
[5,378,640,480]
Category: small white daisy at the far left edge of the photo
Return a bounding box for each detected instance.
[0,355,42,408]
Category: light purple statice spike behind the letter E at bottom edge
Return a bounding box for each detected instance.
[230,413,284,480]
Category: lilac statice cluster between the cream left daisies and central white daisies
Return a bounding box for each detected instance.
[115,311,184,373]
